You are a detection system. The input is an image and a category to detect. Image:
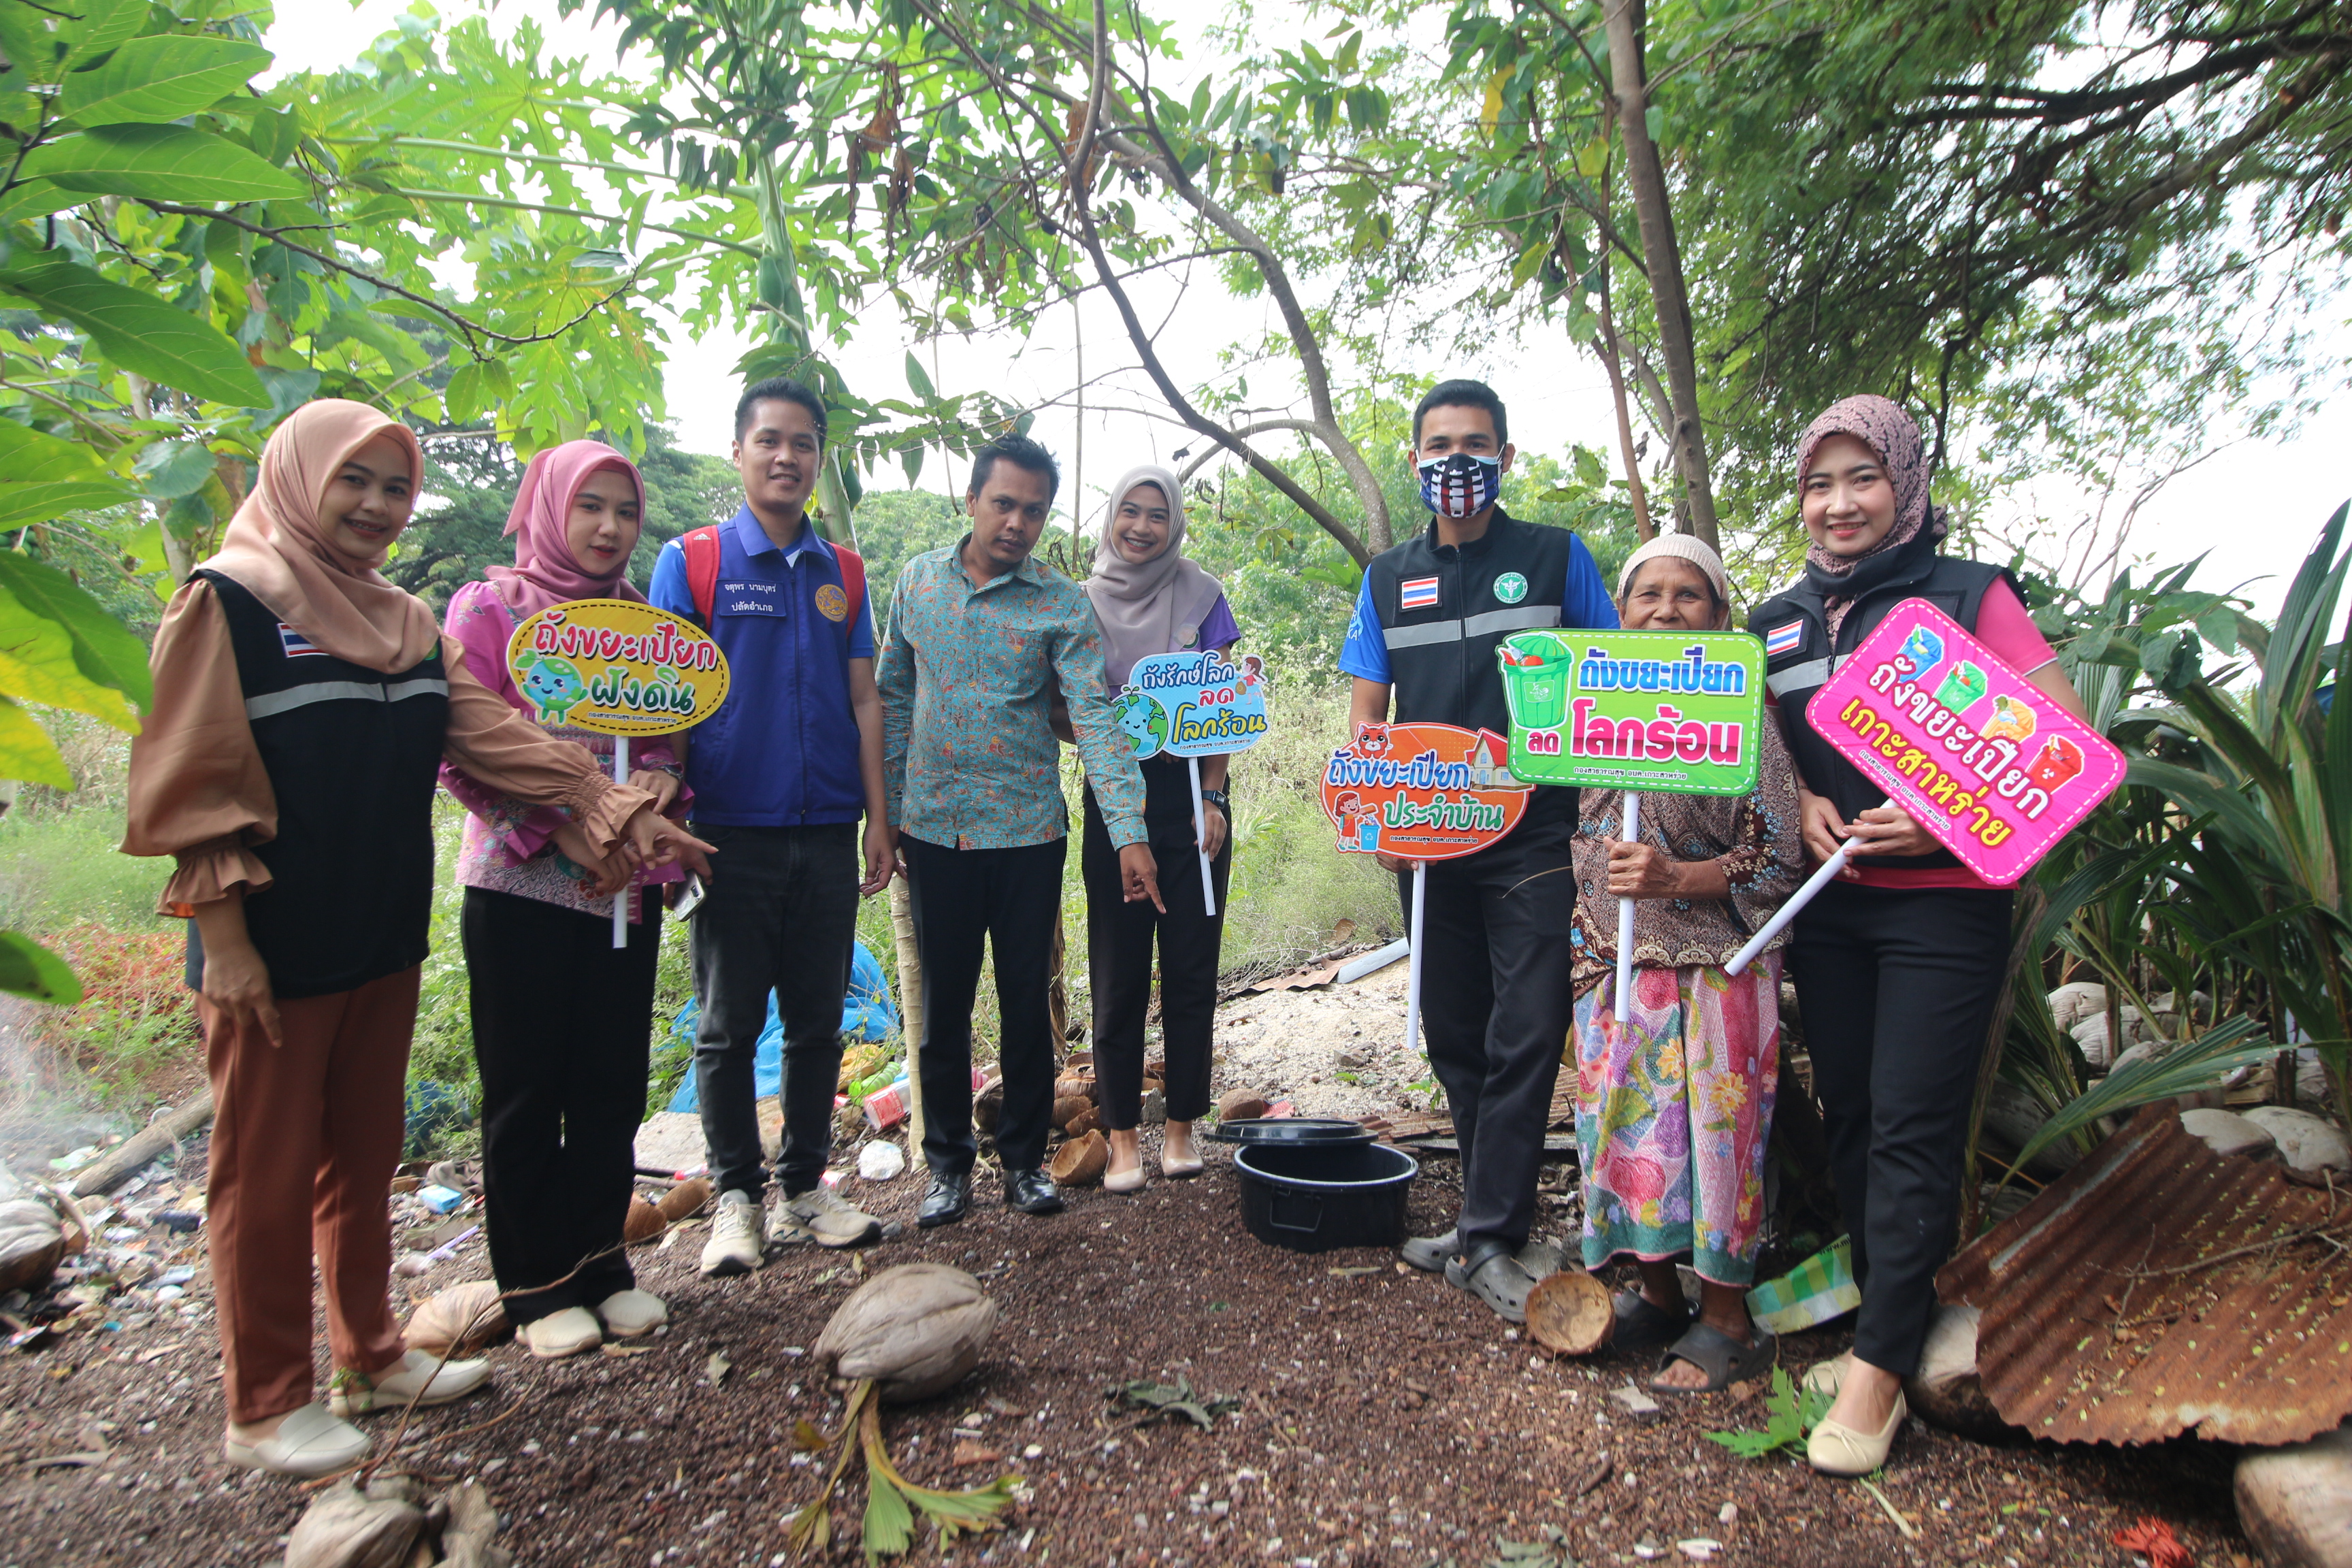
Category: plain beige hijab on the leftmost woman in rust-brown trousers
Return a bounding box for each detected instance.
[205,397,440,674]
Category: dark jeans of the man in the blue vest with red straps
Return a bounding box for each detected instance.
[687,823,858,1196]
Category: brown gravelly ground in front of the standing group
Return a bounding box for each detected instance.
[0,1128,2251,1568]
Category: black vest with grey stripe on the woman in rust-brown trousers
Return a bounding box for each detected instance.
[188,571,449,999]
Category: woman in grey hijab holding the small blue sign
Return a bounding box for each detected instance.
[1082,466,1242,1192]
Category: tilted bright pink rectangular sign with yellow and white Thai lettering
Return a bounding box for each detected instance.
[1804,600,2124,886]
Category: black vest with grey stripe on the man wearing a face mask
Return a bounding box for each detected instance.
[1364,506,1576,825]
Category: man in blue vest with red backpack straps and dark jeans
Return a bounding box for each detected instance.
[647,376,894,1277]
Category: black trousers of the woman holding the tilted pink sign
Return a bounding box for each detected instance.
[1788,881,2011,1375]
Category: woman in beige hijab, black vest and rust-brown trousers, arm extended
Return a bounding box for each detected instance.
[122,399,706,1476]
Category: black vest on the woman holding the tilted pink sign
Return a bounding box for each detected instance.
[1748,553,2025,870]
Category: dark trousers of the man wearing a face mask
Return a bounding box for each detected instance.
[1397,811,1576,1251]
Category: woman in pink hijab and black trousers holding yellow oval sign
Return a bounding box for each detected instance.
[442,442,680,1356]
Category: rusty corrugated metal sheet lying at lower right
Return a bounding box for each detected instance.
[1936,1105,2352,1443]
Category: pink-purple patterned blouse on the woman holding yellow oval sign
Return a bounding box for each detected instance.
[440,583,691,921]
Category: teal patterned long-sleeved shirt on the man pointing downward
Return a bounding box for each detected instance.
[875,536,1145,849]
